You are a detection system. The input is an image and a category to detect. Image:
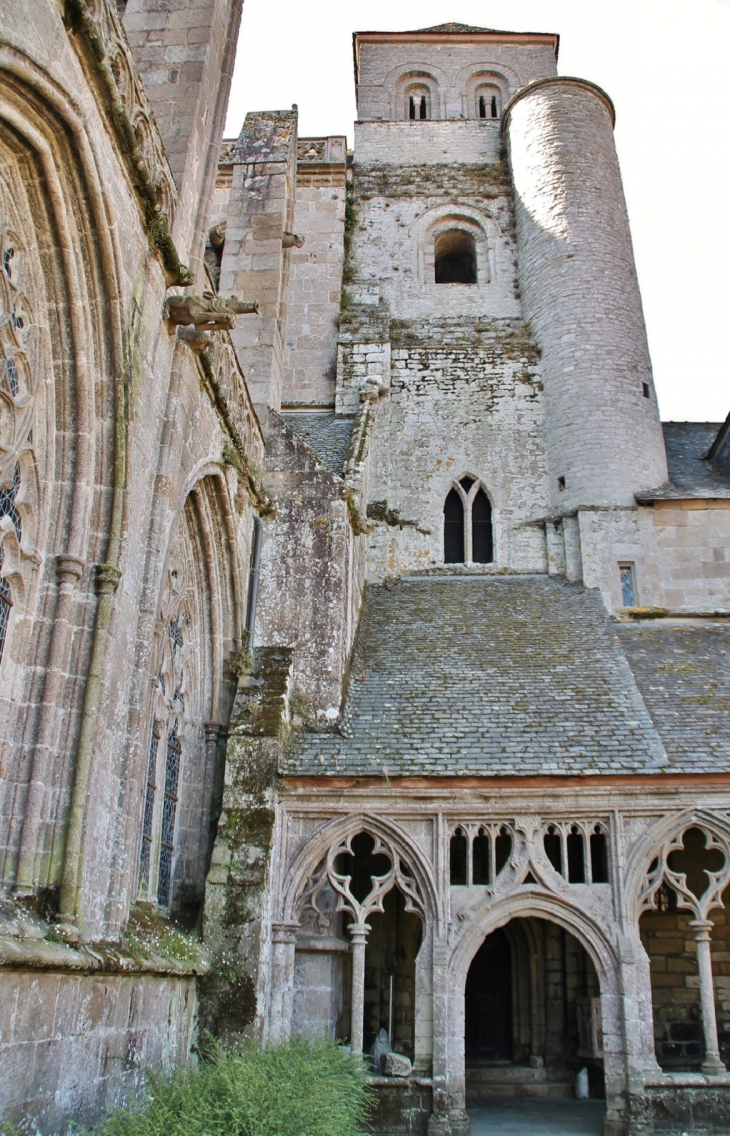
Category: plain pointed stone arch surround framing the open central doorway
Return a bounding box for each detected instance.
[446,886,626,1118]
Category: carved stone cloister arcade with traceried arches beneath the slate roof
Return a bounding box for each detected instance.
[268,812,730,1133]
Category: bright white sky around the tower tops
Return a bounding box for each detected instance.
[226,0,730,421]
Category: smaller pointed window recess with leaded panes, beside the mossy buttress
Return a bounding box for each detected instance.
[137,471,242,921]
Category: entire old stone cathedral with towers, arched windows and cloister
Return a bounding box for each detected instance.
[0,0,730,1136]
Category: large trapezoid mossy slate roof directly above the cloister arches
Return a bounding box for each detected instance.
[283,576,681,777]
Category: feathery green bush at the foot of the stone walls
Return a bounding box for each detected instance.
[98,1038,369,1136]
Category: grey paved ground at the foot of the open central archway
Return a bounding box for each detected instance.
[469,1101,605,1136]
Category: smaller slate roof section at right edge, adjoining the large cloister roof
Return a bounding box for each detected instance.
[618,621,730,770]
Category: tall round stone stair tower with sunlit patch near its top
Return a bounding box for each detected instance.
[503,77,666,511]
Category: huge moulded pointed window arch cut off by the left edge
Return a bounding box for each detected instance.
[0,48,126,888]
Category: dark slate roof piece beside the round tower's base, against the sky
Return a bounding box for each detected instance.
[636,423,730,501]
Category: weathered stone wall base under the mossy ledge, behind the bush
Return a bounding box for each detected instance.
[0,970,198,1131]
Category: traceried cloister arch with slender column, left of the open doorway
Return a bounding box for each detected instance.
[280,813,438,1068]
